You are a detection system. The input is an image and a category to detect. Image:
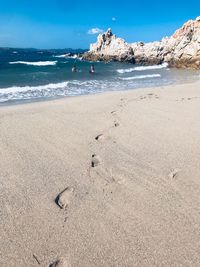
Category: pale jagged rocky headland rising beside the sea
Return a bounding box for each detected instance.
[84,17,200,69]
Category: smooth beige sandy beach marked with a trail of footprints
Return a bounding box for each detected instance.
[0,82,200,267]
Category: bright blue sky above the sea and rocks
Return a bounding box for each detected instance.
[0,0,200,48]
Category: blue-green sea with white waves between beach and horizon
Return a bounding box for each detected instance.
[0,48,200,105]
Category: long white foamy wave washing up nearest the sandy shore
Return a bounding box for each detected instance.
[0,74,160,103]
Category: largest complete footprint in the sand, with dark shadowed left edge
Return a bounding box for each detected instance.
[55,187,74,210]
